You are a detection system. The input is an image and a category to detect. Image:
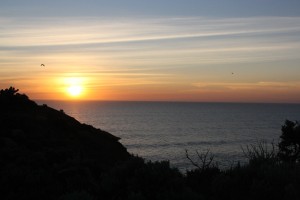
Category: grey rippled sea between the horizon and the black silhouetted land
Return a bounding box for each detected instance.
[38,101,300,171]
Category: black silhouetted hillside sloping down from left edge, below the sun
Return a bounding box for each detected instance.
[0,88,131,199]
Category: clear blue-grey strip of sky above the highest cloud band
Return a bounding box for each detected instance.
[0,0,300,17]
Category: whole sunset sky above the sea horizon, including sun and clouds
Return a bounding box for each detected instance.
[0,0,300,103]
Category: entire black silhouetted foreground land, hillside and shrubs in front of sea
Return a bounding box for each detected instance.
[0,87,300,200]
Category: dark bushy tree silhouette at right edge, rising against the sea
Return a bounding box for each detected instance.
[278,120,300,163]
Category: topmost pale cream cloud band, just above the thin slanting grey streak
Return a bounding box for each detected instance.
[0,17,300,46]
